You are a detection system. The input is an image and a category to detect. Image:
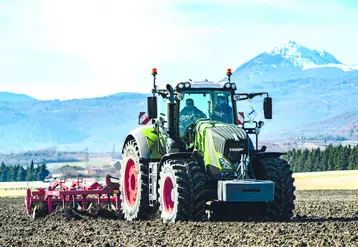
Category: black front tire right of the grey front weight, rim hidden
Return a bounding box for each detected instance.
[253,158,296,220]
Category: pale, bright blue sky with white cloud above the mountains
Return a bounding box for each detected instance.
[0,0,358,99]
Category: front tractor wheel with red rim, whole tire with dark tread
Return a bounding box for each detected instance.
[158,160,205,222]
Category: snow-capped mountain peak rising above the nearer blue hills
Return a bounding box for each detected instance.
[232,41,358,88]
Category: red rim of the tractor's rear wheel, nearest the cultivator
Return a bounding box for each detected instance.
[124,159,138,207]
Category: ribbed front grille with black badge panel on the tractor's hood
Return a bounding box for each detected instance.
[211,126,248,162]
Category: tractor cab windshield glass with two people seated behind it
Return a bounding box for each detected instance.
[179,90,234,135]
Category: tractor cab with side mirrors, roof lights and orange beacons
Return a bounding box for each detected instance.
[147,69,272,153]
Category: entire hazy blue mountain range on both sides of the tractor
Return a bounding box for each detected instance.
[0,41,358,153]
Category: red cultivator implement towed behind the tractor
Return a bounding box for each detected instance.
[25,175,120,218]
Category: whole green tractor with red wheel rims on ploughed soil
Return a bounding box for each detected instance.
[120,69,295,222]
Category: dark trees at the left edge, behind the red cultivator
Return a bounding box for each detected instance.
[0,160,50,182]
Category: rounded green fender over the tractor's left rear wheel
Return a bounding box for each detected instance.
[122,126,160,160]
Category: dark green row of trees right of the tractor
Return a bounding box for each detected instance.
[285,144,358,172]
